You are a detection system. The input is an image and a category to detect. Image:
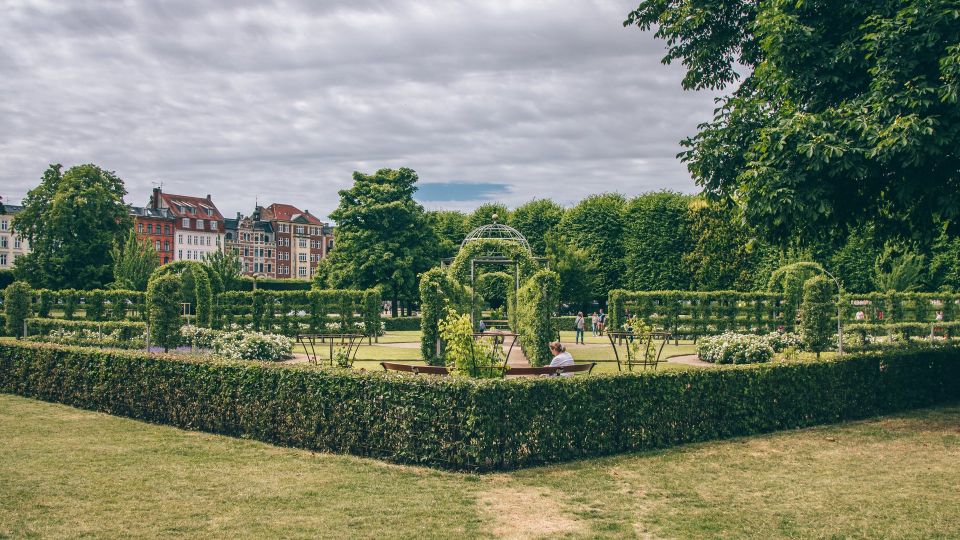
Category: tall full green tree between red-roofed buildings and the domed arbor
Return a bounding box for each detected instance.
[329,168,434,315]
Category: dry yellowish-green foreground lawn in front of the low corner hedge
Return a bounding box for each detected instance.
[0,395,960,538]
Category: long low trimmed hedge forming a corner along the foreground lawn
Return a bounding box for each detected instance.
[0,340,960,471]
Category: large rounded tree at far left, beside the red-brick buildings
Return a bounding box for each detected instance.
[13,165,131,289]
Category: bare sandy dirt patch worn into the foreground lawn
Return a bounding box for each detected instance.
[478,487,583,538]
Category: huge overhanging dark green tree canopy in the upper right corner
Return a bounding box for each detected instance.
[624,0,960,243]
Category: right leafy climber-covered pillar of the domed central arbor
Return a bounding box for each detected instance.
[515,270,560,366]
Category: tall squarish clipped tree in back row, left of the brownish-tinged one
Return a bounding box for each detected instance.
[623,191,691,291]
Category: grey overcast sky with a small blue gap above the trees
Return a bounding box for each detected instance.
[0,0,713,217]
